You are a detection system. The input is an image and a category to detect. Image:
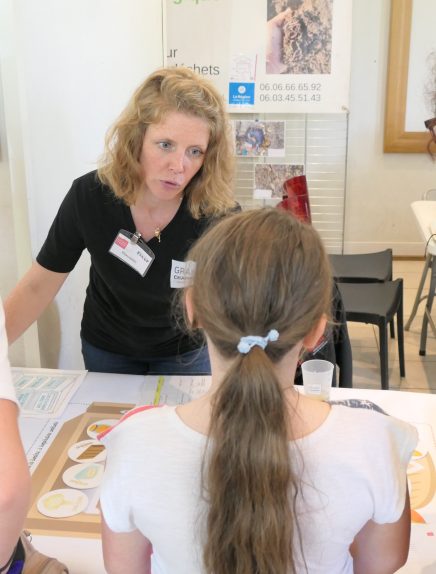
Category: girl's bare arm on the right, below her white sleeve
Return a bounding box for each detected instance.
[350,492,410,574]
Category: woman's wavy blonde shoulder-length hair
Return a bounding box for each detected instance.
[98,67,235,219]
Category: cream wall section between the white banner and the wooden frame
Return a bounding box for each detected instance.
[345,0,436,256]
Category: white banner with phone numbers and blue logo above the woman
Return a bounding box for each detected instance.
[166,0,352,113]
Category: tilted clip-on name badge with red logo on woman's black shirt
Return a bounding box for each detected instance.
[109,229,154,277]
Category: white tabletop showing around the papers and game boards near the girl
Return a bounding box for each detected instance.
[20,373,436,574]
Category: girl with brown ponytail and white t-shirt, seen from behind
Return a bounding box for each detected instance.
[101,209,416,574]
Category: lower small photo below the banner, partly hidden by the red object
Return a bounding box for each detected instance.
[253,163,304,199]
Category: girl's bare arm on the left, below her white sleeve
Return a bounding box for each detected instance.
[101,515,152,574]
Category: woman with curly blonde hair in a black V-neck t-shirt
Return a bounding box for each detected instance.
[5,68,237,374]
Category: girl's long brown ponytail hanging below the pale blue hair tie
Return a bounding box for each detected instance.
[204,347,295,574]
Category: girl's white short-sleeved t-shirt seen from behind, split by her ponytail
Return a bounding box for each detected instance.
[100,405,417,574]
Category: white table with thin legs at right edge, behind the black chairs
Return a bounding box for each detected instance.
[404,201,436,356]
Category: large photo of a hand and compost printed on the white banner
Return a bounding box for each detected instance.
[266,0,333,74]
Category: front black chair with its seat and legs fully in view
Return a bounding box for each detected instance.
[338,279,406,389]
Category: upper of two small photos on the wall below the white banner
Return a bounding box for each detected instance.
[233,120,285,157]
